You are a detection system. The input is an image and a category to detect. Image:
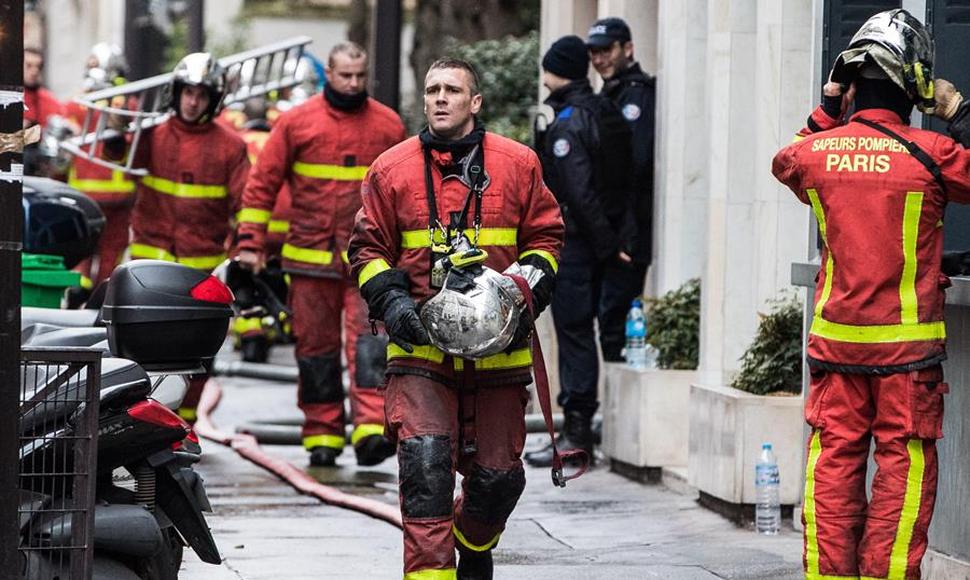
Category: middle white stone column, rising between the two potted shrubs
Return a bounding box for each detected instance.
[699,0,772,384]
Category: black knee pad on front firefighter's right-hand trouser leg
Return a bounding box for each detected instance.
[462,465,525,524]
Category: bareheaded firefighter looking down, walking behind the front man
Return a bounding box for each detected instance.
[237,42,405,466]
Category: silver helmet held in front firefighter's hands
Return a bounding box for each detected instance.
[420,254,526,359]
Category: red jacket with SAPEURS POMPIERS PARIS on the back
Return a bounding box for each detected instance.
[772,109,970,372]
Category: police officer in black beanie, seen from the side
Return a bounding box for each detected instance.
[525,36,643,466]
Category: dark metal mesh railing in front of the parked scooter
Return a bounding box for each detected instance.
[18,347,101,580]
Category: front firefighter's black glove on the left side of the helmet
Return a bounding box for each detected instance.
[360,269,431,352]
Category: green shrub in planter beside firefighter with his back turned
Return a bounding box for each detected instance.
[731,296,802,395]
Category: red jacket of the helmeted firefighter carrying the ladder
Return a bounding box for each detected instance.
[129,116,249,270]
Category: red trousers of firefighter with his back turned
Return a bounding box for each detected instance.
[802,366,948,580]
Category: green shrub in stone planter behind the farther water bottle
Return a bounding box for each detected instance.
[647,278,701,370]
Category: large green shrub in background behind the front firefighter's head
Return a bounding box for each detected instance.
[448,31,539,144]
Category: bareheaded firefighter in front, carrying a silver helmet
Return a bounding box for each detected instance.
[350,59,564,580]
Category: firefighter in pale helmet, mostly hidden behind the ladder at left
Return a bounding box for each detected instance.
[65,42,135,289]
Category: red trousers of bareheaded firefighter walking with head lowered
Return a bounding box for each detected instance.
[289,275,386,449]
